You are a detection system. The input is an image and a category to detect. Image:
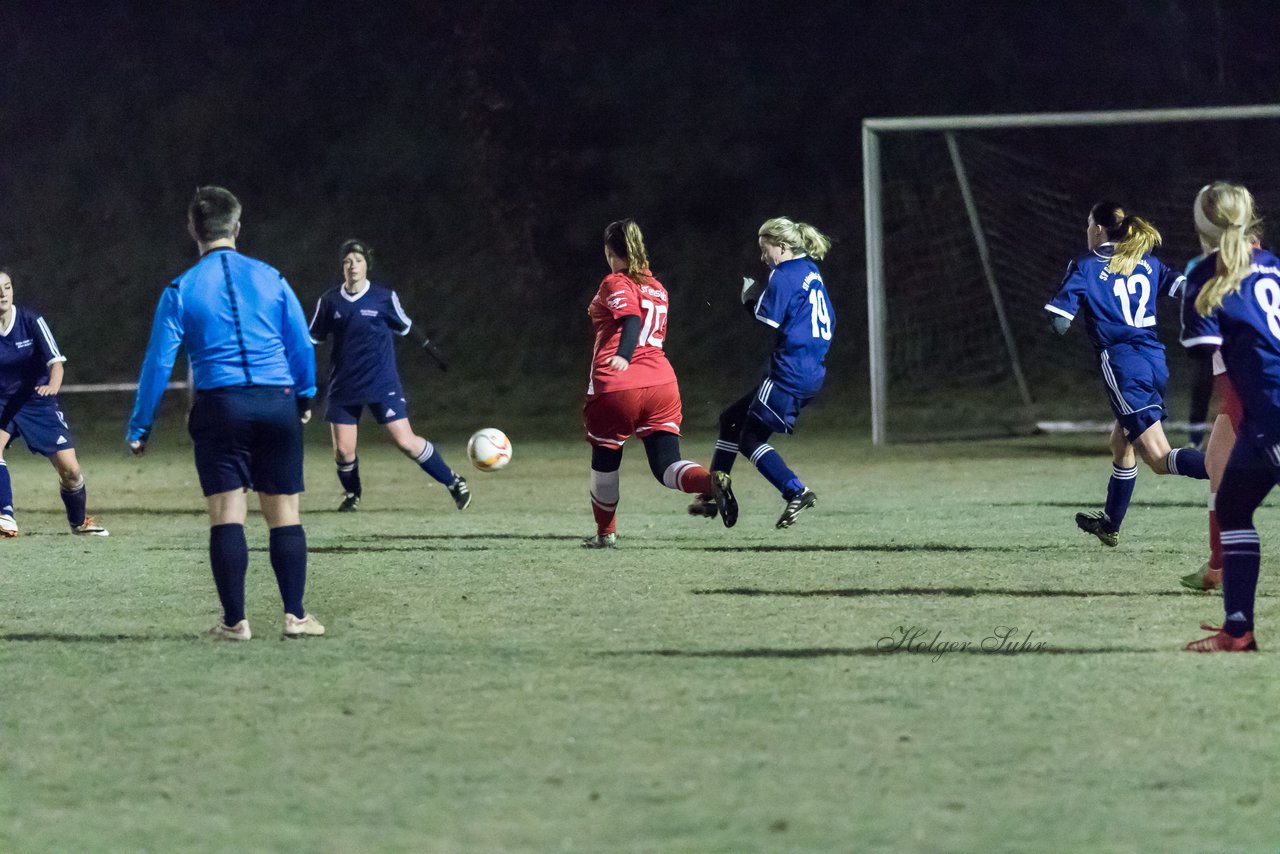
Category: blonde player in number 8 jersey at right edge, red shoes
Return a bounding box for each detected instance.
[1185,182,1280,652]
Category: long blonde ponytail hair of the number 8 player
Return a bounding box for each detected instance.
[1194,181,1260,318]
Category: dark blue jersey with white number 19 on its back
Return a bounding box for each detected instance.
[755,256,836,397]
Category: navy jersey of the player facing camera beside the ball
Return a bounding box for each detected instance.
[311,282,413,406]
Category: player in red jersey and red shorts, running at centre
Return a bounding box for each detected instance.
[582,219,737,548]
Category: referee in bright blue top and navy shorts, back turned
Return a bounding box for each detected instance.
[127,187,324,640]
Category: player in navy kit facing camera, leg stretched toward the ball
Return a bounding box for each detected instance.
[311,241,471,512]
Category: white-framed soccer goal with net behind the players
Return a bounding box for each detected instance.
[863,105,1280,444]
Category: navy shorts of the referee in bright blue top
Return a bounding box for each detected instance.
[187,385,302,495]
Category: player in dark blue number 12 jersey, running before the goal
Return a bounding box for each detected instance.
[1044,202,1207,545]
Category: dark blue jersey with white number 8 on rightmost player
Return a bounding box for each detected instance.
[1187,248,1280,446]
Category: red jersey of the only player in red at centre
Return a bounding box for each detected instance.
[586,273,676,394]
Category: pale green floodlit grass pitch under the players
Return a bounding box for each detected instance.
[0,426,1280,851]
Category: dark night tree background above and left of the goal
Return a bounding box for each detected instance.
[0,0,1280,429]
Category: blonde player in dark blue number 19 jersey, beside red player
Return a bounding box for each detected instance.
[689,216,836,528]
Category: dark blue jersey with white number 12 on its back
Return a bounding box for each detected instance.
[1044,243,1183,352]
